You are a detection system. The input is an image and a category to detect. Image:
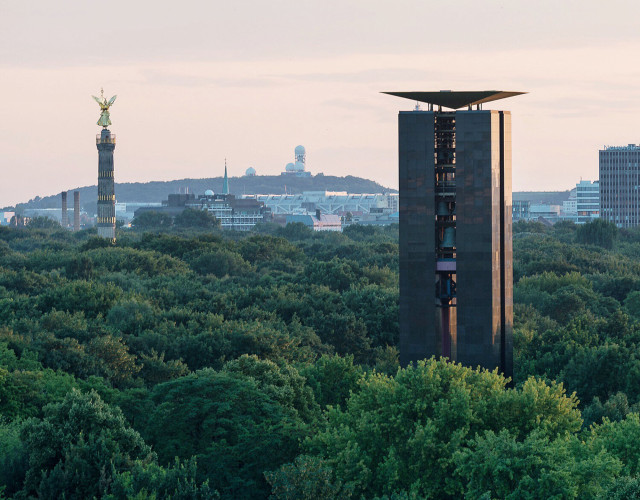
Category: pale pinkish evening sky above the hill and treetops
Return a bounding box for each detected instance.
[0,0,640,206]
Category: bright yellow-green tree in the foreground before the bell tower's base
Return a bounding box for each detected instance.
[298,360,582,498]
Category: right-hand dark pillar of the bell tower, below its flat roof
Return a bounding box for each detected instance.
[456,110,513,377]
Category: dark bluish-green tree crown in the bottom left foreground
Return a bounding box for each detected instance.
[22,390,154,499]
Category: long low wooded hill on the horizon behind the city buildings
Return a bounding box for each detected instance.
[16,174,397,213]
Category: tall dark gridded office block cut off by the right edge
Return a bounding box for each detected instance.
[599,144,640,227]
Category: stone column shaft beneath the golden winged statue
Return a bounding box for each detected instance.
[96,128,116,242]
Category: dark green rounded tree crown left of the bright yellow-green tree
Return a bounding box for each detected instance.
[146,370,306,498]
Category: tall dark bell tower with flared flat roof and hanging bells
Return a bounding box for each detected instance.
[388,91,521,377]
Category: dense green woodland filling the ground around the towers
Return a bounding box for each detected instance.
[0,219,640,500]
